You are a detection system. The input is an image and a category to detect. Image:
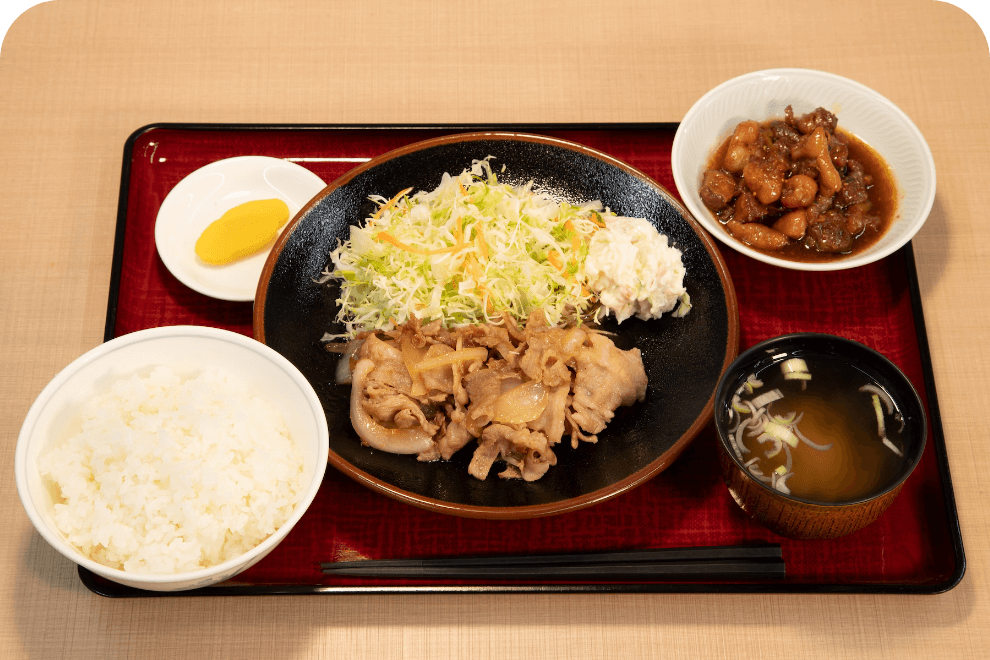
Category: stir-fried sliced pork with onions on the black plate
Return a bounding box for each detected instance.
[341,311,647,481]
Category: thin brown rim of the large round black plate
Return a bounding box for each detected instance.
[254,130,739,520]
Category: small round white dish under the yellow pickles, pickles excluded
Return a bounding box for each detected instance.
[155,156,326,301]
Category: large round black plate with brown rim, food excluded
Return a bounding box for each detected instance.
[254,132,739,519]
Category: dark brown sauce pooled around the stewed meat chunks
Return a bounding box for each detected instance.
[708,126,897,263]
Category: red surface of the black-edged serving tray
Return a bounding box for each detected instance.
[91,126,964,595]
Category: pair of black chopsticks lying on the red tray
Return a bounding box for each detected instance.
[320,544,785,581]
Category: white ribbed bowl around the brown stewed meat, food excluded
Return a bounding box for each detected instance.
[671,69,935,270]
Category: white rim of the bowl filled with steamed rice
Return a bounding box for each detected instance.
[14,325,330,588]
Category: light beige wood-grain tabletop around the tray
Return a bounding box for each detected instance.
[0,0,990,660]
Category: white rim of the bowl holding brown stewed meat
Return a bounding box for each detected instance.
[670,67,937,272]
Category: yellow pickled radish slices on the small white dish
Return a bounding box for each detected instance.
[196,199,289,266]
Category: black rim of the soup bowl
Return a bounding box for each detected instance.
[713,332,928,511]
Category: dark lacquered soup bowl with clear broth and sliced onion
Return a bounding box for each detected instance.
[714,333,927,539]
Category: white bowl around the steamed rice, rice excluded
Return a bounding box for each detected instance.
[14,326,330,591]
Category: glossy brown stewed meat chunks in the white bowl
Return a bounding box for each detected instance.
[699,106,895,261]
